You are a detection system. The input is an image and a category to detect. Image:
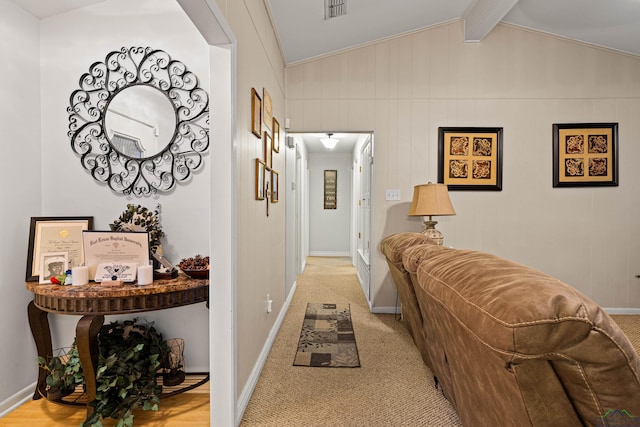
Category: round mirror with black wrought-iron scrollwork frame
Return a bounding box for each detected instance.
[67,47,209,195]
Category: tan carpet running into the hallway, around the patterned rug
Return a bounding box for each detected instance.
[240,257,640,427]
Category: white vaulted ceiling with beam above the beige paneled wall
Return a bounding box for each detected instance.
[265,0,640,64]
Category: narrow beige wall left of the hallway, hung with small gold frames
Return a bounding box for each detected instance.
[211,0,285,402]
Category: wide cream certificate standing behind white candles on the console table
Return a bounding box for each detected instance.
[82,231,149,277]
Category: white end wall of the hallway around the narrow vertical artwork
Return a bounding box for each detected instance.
[309,153,352,256]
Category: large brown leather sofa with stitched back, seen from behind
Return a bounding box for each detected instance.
[381,233,640,427]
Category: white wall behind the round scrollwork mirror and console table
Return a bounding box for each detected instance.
[41,0,210,371]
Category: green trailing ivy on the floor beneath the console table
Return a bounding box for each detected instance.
[41,319,170,427]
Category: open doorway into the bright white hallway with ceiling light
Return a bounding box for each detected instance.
[286,132,374,306]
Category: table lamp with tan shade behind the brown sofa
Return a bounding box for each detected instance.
[407,182,456,245]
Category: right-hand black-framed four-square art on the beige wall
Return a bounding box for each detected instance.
[553,123,618,187]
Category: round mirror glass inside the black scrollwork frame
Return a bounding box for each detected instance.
[104,85,176,159]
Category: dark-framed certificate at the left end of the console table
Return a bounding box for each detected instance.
[25,216,93,282]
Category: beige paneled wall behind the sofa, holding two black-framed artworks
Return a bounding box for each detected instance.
[286,21,640,310]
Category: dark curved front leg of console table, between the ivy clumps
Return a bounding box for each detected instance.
[76,315,104,416]
